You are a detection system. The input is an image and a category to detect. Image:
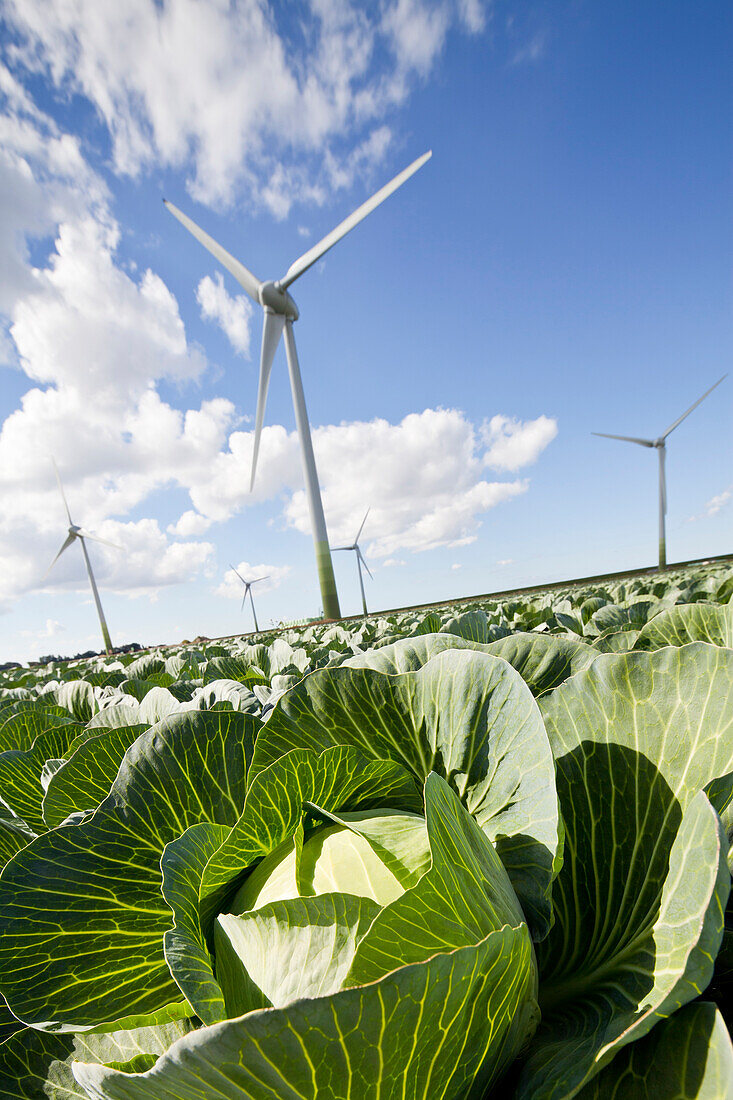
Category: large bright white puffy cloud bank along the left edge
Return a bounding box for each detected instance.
[0,83,225,606]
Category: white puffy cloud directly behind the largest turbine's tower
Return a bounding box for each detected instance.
[190,409,538,558]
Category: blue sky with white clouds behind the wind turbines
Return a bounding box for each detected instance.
[0,0,733,659]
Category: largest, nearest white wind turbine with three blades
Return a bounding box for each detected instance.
[163,152,431,618]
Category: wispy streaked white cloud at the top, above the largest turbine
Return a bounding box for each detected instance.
[6,0,484,209]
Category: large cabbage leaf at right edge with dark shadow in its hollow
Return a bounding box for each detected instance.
[512,644,733,1100]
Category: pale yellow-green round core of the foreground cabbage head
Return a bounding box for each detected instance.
[230,810,430,913]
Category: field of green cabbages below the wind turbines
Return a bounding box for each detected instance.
[0,562,733,1100]
